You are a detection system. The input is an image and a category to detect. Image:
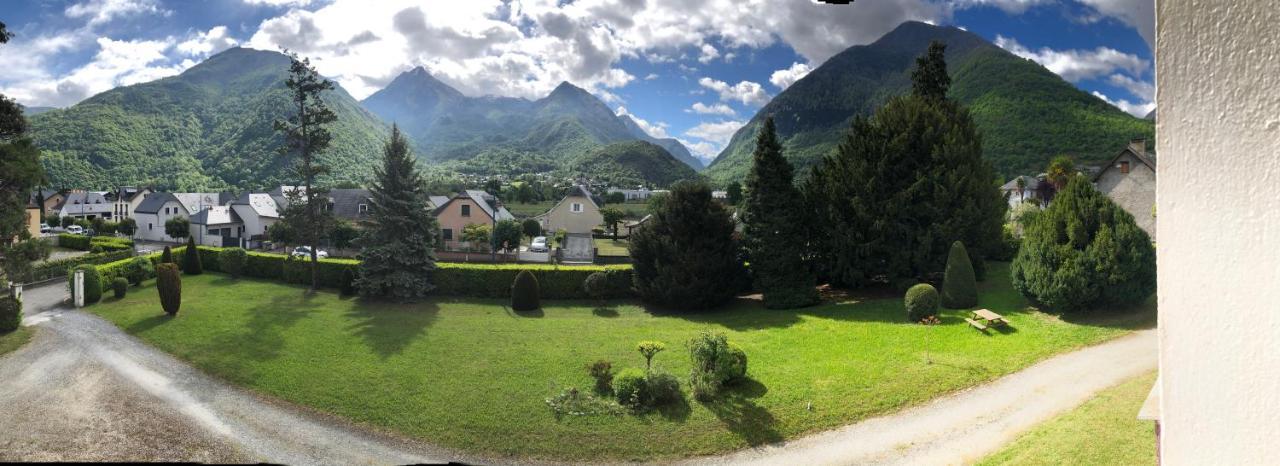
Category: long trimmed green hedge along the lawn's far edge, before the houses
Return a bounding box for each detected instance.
[90,246,632,300]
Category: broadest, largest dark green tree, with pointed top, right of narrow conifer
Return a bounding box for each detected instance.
[803,41,1007,287]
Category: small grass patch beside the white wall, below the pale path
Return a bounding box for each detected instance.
[980,373,1156,466]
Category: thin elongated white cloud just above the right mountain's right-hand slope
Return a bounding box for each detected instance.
[996,35,1151,82]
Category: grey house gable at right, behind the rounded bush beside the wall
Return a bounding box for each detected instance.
[1093,140,1156,241]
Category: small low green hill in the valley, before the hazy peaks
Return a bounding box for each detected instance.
[568,141,698,186]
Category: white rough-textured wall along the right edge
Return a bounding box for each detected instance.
[1156,0,1280,465]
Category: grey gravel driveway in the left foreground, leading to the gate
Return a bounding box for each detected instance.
[0,283,456,465]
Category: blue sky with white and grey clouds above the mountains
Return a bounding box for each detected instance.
[0,0,1155,160]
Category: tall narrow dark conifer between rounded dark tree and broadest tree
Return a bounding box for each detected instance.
[742,117,818,309]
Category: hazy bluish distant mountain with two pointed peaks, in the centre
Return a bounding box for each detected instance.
[362,67,701,174]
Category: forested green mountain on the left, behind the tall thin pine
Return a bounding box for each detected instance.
[31,47,389,191]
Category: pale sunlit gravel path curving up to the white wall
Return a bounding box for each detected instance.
[689,330,1156,465]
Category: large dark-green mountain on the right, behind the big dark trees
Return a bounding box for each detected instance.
[705,22,1155,183]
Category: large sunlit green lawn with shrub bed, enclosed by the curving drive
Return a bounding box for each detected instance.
[90,264,1153,461]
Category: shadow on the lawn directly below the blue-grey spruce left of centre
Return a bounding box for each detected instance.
[347,300,440,360]
